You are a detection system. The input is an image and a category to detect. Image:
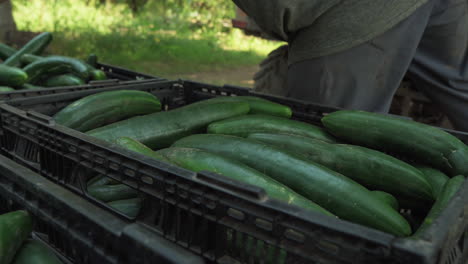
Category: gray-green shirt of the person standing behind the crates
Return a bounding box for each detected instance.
[233,0,428,64]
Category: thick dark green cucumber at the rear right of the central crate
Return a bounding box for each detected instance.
[322,110,468,176]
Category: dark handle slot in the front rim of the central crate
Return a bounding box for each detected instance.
[196,171,267,200]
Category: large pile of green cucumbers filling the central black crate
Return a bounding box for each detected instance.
[54,91,468,237]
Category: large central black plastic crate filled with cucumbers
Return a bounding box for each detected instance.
[0,79,468,264]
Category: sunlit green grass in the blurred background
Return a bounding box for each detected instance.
[13,0,280,77]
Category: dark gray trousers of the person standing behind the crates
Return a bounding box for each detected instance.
[287,0,468,131]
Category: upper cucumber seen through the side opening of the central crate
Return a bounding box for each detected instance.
[88,184,138,202]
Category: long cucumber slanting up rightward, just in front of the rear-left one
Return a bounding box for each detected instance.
[87,99,250,149]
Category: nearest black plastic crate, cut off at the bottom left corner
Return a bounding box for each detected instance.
[0,156,207,264]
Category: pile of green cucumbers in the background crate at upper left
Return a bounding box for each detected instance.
[0,32,107,92]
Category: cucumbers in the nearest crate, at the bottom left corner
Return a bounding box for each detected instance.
[0,211,62,264]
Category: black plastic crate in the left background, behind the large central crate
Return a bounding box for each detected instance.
[0,63,165,101]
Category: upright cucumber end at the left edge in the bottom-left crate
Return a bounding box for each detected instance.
[0,211,32,264]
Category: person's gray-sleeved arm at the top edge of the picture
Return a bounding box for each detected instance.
[233,0,341,41]
